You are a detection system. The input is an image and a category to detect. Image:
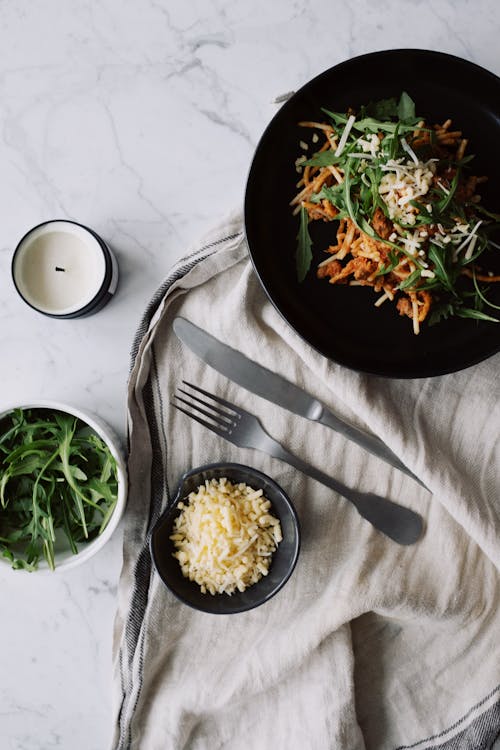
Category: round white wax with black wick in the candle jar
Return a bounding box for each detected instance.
[13,221,106,315]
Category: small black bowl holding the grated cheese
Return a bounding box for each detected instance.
[150,463,300,615]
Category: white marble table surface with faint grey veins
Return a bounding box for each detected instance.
[0,0,500,750]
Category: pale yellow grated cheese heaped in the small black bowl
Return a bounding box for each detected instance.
[170,477,283,594]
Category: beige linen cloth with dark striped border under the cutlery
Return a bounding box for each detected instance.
[112,216,500,750]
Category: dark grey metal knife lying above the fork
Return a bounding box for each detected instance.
[173,317,425,487]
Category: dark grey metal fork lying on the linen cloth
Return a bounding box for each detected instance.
[172,380,423,544]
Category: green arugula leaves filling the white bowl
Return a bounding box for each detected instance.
[0,408,118,571]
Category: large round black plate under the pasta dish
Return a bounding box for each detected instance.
[245,50,500,378]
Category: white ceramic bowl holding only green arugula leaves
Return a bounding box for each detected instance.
[0,400,128,575]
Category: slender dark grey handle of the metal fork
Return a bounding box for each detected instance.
[261,436,423,545]
